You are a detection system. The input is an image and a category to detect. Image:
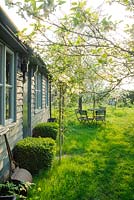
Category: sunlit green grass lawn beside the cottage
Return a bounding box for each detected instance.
[27,108,134,200]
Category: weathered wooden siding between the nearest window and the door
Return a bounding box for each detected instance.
[0,69,23,181]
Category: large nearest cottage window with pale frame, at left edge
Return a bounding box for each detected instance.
[0,44,15,125]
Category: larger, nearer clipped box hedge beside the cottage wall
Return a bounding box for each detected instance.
[13,137,56,174]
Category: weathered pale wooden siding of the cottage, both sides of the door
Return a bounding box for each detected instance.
[0,67,49,181]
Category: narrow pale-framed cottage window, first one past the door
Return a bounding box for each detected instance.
[35,72,42,109]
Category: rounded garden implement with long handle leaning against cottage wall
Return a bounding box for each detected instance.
[4,134,32,183]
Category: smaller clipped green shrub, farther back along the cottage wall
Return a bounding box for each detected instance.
[32,122,58,140]
